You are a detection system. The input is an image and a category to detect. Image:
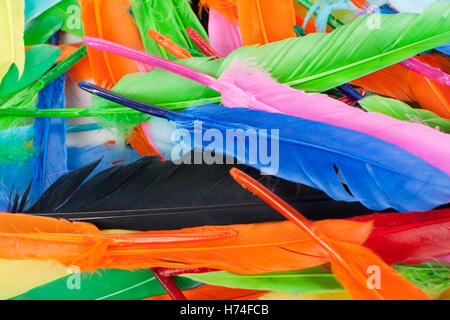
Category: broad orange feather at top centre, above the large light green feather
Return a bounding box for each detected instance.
[237,0,296,46]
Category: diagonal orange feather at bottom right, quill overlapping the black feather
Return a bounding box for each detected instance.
[230,168,429,300]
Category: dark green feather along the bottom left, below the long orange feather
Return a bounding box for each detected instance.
[11,269,198,300]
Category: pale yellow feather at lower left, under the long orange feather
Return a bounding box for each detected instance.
[0,259,72,300]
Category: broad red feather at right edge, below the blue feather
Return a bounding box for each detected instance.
[354,209,450,264]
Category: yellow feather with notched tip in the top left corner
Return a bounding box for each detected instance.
[0,0,25,79]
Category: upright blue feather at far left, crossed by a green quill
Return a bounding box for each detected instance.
[31,76,67,198]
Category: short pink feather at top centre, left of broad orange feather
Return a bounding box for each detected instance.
[208,8,243,57]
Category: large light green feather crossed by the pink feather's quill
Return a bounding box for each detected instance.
[86,3,449,121]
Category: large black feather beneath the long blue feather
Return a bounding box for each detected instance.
[27,151,380,230]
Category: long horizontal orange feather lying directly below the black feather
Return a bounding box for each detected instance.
[0,214,372,274]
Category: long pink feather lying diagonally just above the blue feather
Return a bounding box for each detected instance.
[84,37,450,175]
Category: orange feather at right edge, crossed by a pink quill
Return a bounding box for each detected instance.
[351,55,450,119]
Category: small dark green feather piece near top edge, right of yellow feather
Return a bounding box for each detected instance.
[23,17,64,46]
